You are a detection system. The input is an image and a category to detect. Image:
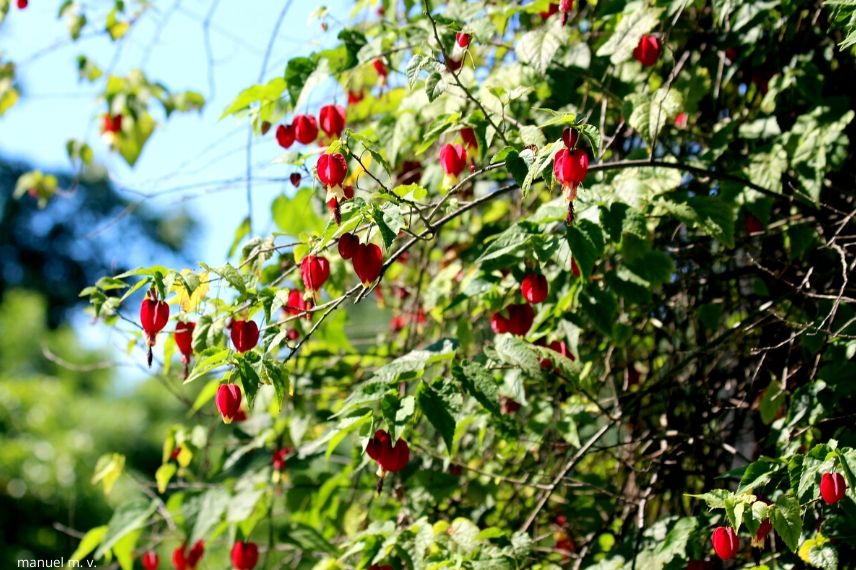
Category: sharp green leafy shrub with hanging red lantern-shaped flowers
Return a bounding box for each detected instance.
[0,0,856,570]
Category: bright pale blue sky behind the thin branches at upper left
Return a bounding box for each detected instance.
[0,0,353,263]
